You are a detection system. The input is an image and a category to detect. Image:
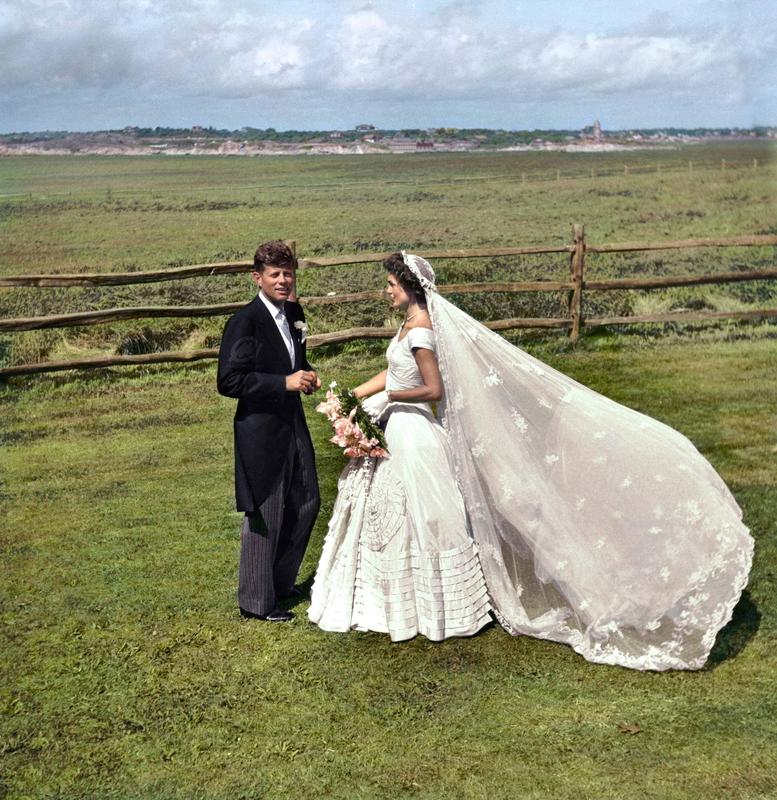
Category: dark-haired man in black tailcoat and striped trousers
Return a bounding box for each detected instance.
[218,241,321,622]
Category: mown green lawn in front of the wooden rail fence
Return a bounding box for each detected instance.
[0,326,777,800]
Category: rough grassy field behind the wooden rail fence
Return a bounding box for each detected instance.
[0,142,777,365]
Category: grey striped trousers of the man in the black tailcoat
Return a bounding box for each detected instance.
[237,419,320,614]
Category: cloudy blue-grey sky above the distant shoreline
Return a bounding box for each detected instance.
[0,0,777,133]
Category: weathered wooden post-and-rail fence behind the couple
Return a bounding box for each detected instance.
[0,225,777,376]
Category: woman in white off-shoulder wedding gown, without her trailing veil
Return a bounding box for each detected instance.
[308,253,491,641]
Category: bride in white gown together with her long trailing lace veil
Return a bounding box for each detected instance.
[308,253,753,670]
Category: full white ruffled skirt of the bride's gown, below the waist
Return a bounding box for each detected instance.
[308,406,491,641]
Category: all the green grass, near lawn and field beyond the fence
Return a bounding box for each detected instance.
[0,144,777,800]
